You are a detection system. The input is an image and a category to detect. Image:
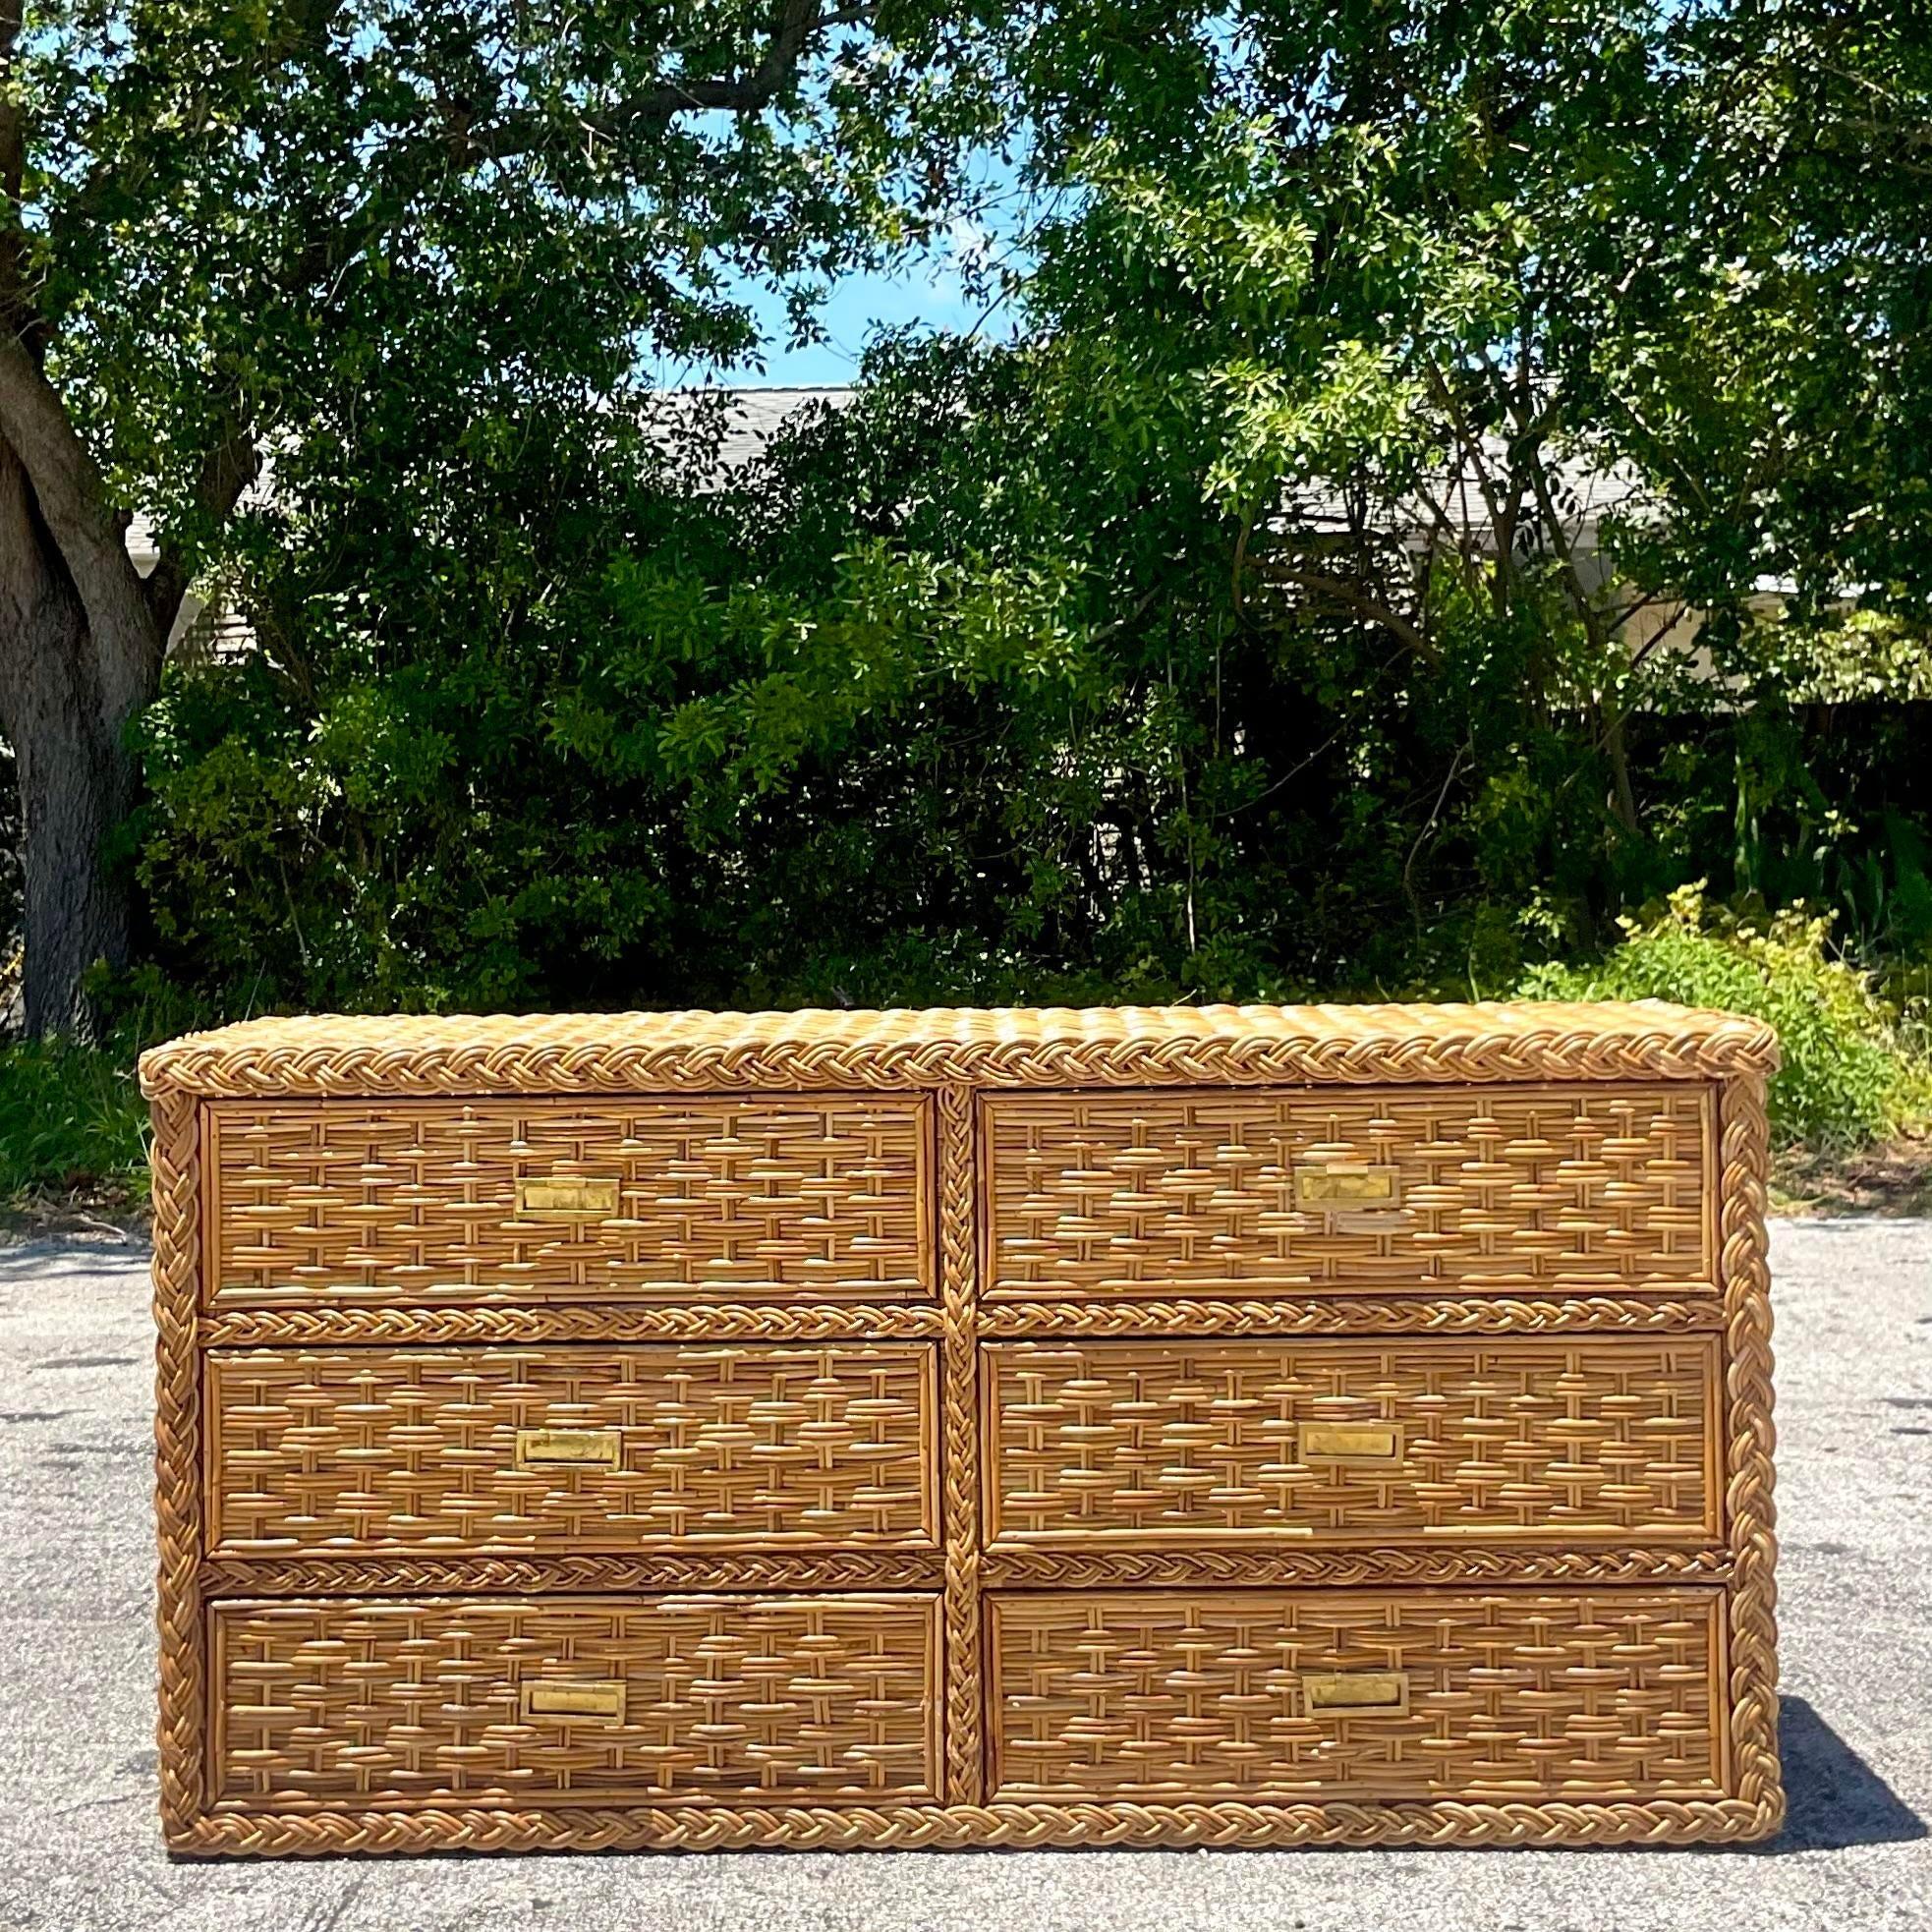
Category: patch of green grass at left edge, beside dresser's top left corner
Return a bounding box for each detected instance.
[0,1042,146,1206]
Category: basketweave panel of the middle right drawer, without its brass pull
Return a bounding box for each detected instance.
[984,1335,1718,1546]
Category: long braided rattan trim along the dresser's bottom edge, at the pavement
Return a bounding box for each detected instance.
[168,1798,1780,1856]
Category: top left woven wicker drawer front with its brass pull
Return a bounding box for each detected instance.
[210,1096,934,1306]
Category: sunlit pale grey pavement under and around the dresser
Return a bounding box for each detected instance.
[0,1222,1932,1932]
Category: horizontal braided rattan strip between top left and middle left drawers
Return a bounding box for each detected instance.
[200,1304,942,1348]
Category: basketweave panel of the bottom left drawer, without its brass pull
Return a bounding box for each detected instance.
[214,1596,938,1808]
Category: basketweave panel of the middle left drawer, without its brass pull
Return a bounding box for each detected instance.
[206,1342,938,1556]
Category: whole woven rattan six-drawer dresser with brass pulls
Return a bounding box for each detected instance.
[142,1004,1784,1852]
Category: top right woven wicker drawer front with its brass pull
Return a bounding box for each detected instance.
[986,1084,1714,1298]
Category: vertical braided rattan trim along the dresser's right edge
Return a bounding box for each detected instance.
[1718,1076,1786,1832]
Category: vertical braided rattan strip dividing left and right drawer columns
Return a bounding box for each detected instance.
[938,1088,986,1804]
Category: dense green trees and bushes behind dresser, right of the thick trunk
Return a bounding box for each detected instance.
[11,0,1932,1004]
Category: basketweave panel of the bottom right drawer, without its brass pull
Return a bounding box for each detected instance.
[992,1590,1722,1802]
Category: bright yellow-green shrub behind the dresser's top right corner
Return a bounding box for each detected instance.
[1520,884,1932,1148]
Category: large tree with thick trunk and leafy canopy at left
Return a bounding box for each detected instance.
[0,0,996,1028]
